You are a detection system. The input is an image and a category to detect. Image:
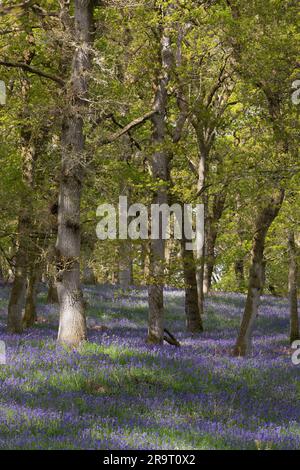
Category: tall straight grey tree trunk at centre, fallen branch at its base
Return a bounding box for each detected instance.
[148,15,172,344]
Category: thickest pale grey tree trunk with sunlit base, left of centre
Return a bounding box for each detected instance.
[56,0,94,346]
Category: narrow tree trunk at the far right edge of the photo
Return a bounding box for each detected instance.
[288,231,300,343]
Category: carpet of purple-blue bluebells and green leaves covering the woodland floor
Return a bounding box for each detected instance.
[0,285,300,450]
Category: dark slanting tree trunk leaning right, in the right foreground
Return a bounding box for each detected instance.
[234,190,284,356]
